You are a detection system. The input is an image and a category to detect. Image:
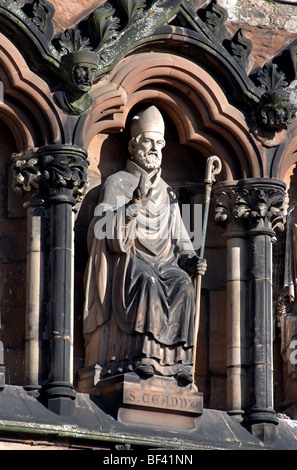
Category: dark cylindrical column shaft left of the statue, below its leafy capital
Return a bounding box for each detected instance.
[45,197,75,414]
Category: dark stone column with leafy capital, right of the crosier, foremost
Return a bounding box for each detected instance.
[216,178,285,440]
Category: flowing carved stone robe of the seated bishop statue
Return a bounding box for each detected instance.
[84,160,195,377]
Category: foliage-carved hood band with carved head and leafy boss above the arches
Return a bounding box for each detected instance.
[0,0,296,131]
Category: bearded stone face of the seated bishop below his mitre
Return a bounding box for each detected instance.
[130,132,165,171]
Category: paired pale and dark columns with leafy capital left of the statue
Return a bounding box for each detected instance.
[13,145,88,415]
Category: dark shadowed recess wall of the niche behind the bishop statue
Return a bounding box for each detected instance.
[74,107,224,403]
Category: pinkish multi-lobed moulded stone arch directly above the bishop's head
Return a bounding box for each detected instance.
[75,52,263,180]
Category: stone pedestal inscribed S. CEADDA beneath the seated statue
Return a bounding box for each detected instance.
[79,370,203,431]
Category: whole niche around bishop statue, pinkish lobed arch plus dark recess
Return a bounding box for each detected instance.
[74,51,264,400]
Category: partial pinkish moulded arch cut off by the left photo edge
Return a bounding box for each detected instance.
[0,32,63,150]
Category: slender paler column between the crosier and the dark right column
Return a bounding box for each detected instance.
[214,182,250,422]
